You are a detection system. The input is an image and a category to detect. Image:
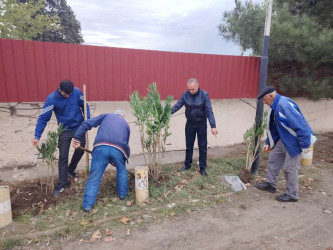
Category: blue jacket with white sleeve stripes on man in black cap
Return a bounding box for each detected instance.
[35,87,90,139]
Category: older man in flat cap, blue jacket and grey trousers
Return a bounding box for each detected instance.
[256,86,316,202]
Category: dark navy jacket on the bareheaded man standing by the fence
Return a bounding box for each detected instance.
[171,88,216,128]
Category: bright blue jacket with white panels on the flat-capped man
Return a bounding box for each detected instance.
[266,94,316,157]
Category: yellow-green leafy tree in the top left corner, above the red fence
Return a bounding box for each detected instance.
[0,0,59,40]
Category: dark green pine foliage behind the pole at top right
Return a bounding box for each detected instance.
[218,0,333,99]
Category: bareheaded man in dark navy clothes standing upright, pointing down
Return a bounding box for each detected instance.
[171,78,218,176]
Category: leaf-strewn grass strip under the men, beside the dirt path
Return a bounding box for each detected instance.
[0,156,245,249]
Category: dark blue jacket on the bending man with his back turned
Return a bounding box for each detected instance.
[74,113,130,159]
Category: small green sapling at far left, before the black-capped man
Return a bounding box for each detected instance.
[36,124,65,193]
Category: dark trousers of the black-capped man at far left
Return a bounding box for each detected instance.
[58,130,86,187]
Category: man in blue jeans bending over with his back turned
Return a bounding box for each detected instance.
[73,111,130,212]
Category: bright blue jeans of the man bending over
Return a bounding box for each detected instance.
[82,145,128,210]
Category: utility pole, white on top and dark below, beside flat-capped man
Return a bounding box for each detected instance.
[251,0,273,174]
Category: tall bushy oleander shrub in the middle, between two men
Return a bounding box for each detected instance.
[130,83,173,180]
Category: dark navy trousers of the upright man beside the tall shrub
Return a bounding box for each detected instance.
[185,121,207,169]
